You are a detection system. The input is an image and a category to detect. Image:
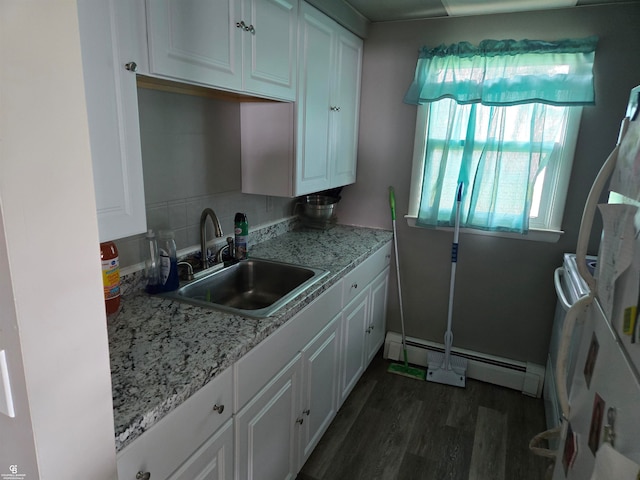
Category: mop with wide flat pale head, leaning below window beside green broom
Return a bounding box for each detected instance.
[427,183,467,387]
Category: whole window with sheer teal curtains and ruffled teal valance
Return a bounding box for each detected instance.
[404,37,597,238]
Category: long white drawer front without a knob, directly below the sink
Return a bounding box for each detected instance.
[234,282,342,412]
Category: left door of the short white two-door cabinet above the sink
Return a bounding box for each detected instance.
[147,0,245,90]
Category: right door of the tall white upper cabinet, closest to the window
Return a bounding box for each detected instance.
[331,27,362,187]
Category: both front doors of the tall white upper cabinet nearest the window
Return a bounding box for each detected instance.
[295,3,362,196]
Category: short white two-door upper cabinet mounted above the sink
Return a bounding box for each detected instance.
[147,0,298,100]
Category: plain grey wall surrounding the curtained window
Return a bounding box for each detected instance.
[340,3,640,364]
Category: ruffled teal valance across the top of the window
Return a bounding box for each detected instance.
[404,36,598,106]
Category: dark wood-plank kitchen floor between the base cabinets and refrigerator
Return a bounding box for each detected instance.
[297,353,549,480]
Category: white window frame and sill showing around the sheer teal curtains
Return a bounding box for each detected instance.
[405,104,582,243]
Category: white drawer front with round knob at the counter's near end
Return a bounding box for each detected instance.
[118,368,233,480]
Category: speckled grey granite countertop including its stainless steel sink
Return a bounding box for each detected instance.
[107,225,392,451]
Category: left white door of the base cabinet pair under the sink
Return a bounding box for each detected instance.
[236,354,302,480]
